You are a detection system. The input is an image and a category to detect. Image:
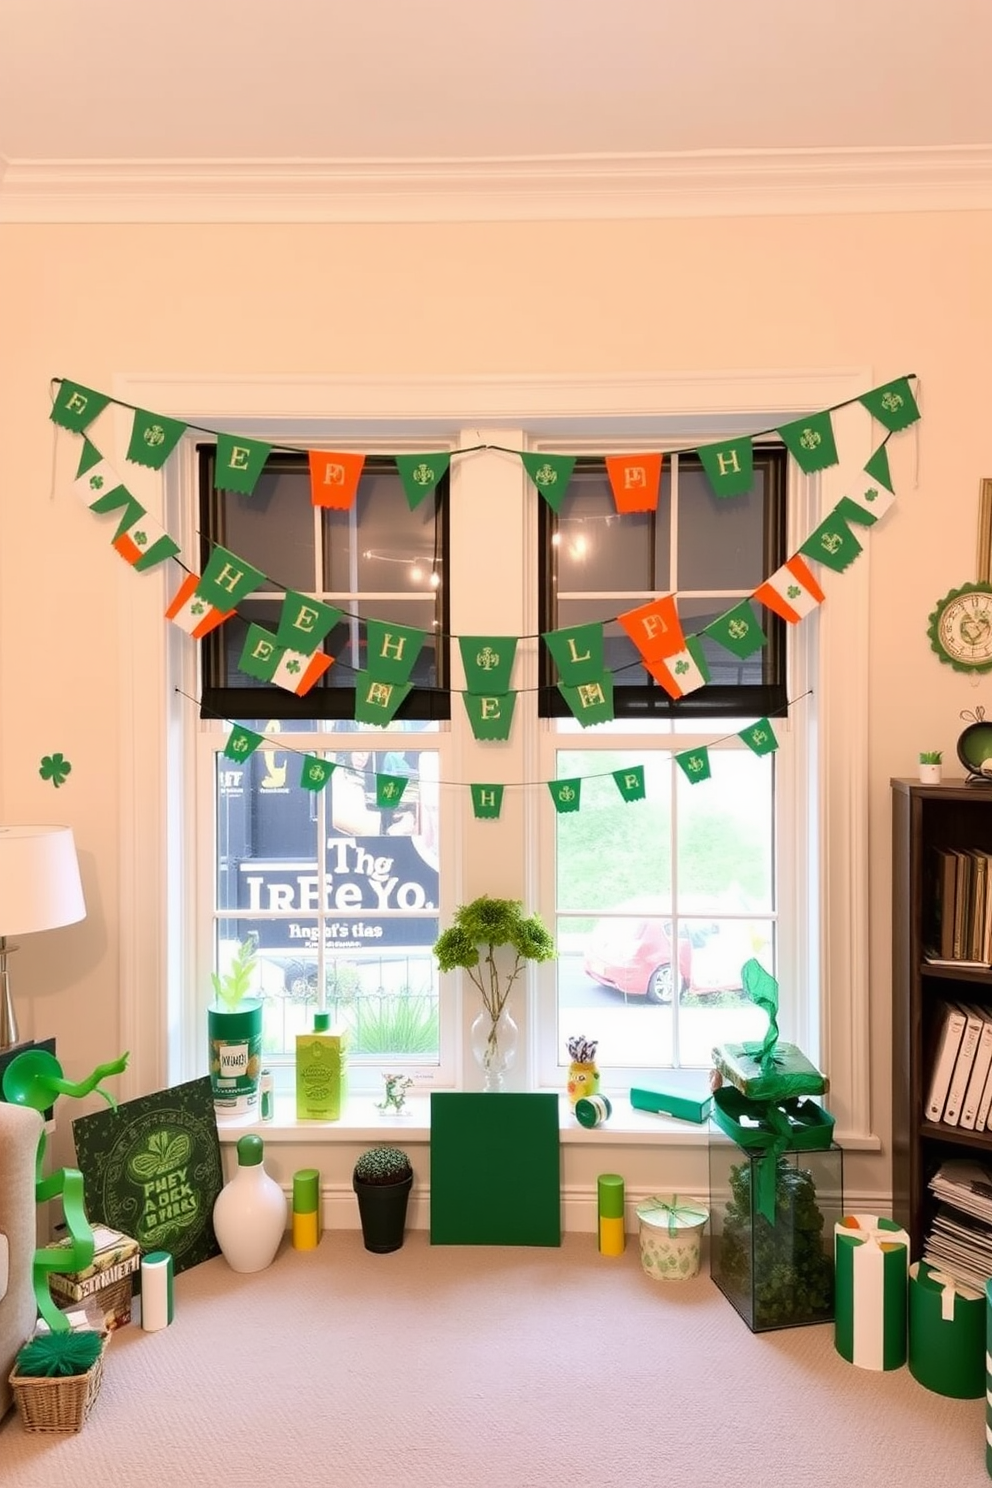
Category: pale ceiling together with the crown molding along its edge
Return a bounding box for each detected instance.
[0,0,992,220]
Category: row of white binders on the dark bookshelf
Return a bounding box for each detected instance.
[924,1001,992,1131]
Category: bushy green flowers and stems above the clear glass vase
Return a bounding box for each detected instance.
[434,894,556,1024]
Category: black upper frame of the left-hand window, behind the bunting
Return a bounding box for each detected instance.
[196,443,451,723]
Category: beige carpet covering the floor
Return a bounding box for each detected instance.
[0,1231,989,1488]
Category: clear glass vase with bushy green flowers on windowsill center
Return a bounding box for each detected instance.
[434,894,555,1091]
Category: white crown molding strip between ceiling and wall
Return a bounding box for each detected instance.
[0,144,992,223]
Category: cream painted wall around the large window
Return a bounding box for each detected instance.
[0,213,992,1195]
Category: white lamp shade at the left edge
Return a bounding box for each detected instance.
[0,826,86,936]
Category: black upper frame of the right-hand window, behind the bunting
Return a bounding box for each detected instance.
[538,445,788,722]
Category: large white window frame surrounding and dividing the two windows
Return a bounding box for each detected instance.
[113,368,877,1147]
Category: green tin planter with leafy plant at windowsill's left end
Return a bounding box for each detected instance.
[207,933,263,1116]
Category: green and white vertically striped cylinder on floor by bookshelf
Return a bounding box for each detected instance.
[834,1214,909,1369]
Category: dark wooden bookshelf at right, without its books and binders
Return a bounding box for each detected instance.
[891,780,992,1259]
